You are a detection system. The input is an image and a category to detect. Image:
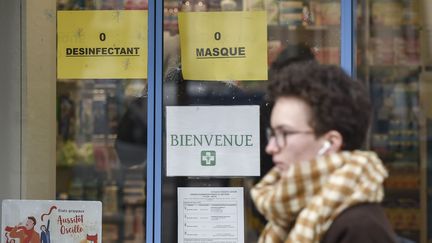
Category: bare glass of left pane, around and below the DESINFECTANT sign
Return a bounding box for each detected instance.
[56,0,147,242]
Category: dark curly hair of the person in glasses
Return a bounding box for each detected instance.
[267,61,372,150]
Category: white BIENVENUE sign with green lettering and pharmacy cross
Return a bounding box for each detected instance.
[166,106,260,176]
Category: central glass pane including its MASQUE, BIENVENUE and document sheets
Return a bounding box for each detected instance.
[162,0,341,243]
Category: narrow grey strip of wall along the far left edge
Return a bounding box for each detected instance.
[0,0,21,205]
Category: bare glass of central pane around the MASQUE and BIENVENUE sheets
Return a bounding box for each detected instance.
[162,0,340,243]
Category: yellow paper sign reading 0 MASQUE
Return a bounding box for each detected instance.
[179,11,267,80]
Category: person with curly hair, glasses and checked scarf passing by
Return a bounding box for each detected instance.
[251,61,396,243]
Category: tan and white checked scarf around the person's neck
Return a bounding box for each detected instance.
[251,151,387,243]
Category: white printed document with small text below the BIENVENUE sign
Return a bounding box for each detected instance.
[177,187,244,243]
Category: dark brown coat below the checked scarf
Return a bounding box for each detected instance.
[321,203,398,243]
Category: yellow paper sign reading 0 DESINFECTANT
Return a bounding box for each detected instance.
[57,10,147,79]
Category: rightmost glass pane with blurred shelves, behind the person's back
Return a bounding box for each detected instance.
[357,0,424,242]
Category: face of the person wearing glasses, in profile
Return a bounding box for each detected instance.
[266,97,323,172]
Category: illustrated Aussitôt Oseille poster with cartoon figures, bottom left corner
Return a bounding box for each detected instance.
[1,200,102,243]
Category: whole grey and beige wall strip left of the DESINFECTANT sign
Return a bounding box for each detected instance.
[0,0,56,223]
